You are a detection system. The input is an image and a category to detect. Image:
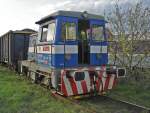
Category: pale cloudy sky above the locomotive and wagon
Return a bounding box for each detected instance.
[0,0,150,35]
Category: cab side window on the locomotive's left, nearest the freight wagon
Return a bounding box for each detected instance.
[41,23,55,42]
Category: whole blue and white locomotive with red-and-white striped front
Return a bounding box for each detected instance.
[20,11,125,96]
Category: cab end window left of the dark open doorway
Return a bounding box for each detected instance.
[61,22,77,40]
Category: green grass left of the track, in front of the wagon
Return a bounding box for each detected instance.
[0,66,84,113]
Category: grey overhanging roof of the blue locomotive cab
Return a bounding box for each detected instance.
[36,10,104,24]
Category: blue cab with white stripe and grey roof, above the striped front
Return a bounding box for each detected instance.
[37,11,108,68]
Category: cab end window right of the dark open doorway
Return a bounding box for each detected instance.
[92,24,104,41]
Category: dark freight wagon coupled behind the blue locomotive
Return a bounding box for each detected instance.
[0,29,35,69]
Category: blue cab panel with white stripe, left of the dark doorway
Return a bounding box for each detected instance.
[56,17,78,68]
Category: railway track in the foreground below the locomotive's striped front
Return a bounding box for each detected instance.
[50,90,150,113]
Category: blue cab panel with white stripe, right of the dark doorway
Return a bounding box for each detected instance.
[90,20,108,66]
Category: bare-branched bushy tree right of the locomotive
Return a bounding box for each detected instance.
[107,1,150,74]
